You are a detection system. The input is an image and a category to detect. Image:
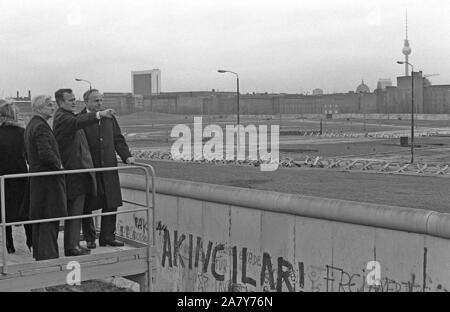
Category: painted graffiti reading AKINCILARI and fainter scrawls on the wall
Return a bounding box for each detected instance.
[157,222,446,292]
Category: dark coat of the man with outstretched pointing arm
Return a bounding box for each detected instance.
[53,107,98,200]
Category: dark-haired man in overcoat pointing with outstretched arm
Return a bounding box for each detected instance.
[53,89,116,256]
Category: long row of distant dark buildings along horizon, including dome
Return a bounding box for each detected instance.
[16,71,450,115]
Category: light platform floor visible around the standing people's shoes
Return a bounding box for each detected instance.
[0,226,135,266]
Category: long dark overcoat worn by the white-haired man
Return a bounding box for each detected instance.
[25,116,67,220]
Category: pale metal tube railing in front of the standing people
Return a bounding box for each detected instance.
[0,163,156,291]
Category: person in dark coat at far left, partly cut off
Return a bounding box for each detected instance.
[0,100,31,253]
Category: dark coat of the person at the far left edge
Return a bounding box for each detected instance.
[0,125,28,222]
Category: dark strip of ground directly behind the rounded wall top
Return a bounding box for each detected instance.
[129,161,450,213]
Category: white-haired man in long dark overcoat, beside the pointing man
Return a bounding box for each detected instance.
[25,95,67,260]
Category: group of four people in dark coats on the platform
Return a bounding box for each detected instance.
[0,89,135,260]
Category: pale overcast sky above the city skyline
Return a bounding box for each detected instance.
[0,0,450,97]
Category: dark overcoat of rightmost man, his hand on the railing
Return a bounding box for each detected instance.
[80,109,131,212]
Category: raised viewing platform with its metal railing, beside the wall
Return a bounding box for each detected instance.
[0,164,156,292]
